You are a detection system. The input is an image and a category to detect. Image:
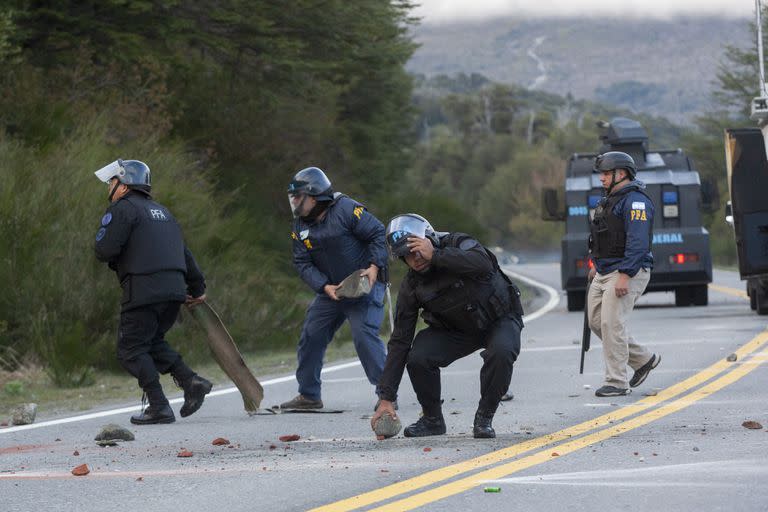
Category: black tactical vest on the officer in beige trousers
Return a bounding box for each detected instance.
[589,187,652,258]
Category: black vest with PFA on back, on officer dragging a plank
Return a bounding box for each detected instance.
[117,194,187,281]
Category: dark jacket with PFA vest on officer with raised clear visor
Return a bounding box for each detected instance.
[95,191,205,311]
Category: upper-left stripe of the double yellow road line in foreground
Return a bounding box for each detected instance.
[312,331,768,512]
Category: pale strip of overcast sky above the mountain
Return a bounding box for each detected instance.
[414,0,766,23]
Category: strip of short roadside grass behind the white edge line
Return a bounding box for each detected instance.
[0,281,537,424]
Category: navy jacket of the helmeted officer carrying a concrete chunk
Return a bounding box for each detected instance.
[291,194,388,293]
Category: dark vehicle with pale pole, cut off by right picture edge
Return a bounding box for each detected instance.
[725,2,768,315]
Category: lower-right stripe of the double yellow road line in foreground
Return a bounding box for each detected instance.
[371,340,768,512]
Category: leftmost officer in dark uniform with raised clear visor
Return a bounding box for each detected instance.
[95,160,212,425]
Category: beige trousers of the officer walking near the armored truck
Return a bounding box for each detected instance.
[587,269,652,389]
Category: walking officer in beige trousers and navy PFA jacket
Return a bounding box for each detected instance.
[587,151,661,397]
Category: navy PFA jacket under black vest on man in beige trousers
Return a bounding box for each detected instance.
[594,180,654,277]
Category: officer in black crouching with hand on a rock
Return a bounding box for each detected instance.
[371,213,523,438]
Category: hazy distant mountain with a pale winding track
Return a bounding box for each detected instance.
[408,17,756,122]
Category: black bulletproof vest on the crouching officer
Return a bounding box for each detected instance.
[414,235,522,333]
